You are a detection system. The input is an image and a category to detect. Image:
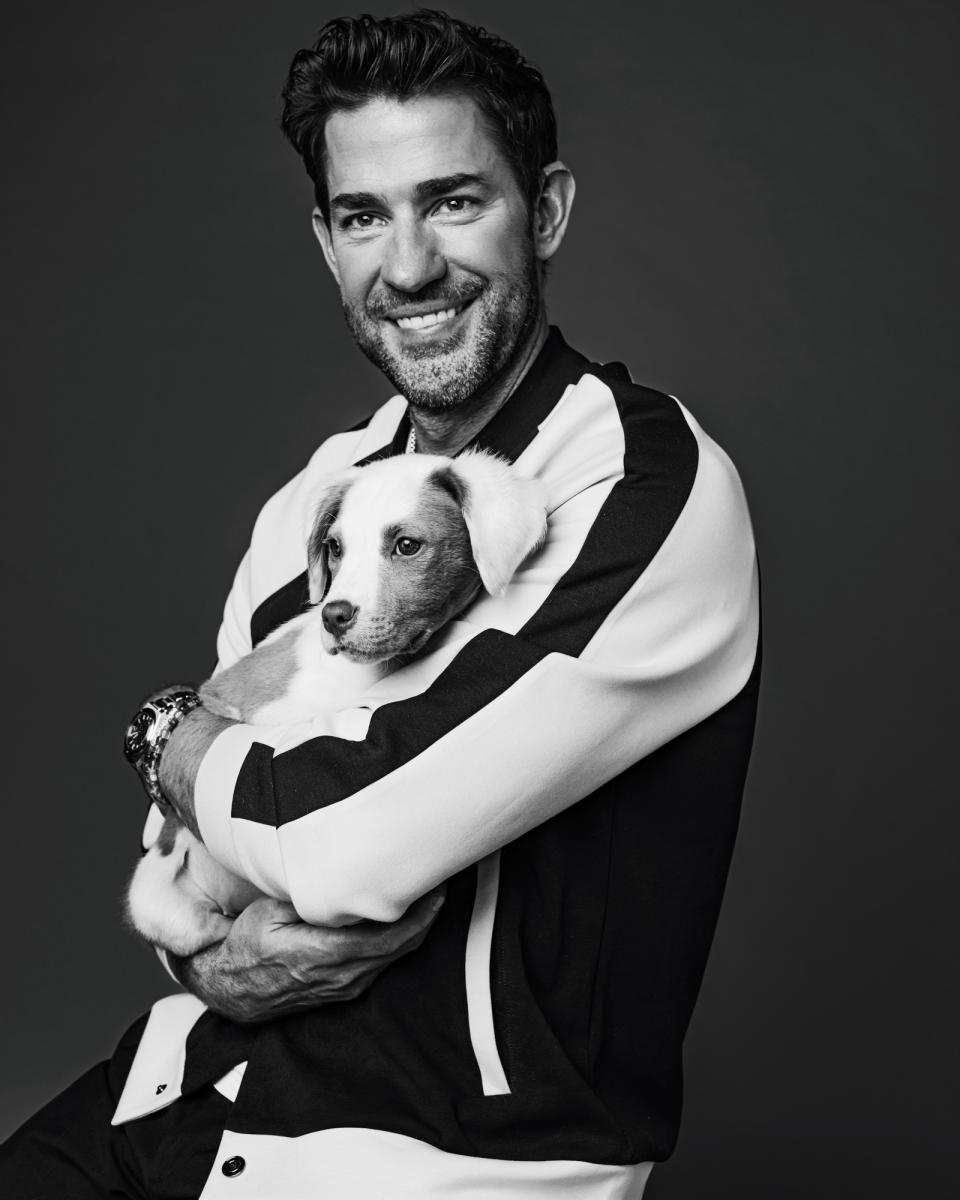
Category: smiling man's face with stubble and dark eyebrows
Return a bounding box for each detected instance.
[318,96,540,409]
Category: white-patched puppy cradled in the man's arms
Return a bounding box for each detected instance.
[127,451,546,954]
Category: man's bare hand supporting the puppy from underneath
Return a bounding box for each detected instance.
[169,892,444,1024]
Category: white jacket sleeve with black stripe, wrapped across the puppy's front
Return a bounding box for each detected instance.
[196,402,758,925]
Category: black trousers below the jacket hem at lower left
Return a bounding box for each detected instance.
[0,1016,233,1200]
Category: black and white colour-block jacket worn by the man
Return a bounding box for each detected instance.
[115,330,760,1200]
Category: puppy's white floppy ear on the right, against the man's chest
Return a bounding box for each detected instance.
[434,450,547,595]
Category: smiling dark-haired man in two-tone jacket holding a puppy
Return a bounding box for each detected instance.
[0,13,758,1200]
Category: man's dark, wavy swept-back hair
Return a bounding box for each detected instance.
[281,8,557,222]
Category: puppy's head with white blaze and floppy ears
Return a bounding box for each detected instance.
[307,452,546,662]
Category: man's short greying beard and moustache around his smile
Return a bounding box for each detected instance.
[343,247,540,410]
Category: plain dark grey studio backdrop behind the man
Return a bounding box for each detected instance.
[0,0,960,1200]
